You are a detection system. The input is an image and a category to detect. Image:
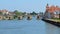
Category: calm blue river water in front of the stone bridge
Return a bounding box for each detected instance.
[0,18,60,34]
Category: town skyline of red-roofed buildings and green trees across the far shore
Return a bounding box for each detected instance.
[0,4,60,19]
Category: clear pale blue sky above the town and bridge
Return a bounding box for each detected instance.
[0,0,60,13]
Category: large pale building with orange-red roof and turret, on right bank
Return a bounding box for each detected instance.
[44,4,60,18]
